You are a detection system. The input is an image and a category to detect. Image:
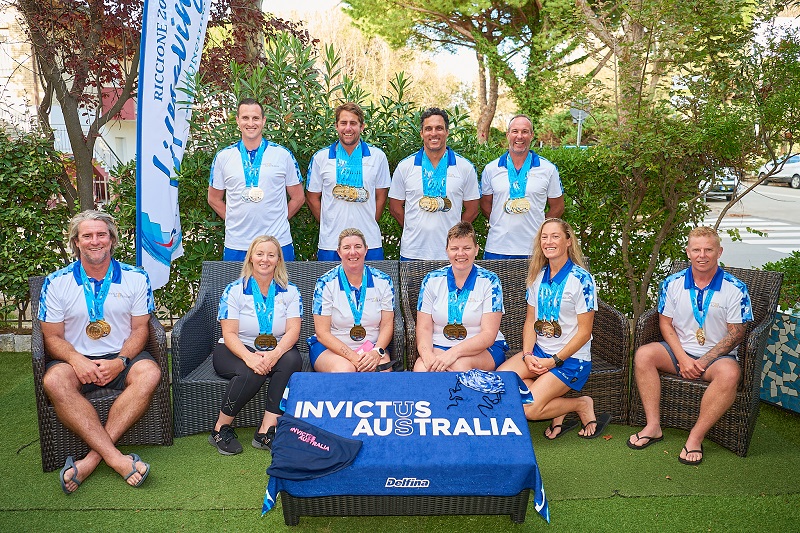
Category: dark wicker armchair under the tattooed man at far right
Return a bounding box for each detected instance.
[629,261,783,457]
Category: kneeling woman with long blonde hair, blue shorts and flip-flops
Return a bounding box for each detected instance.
[498,218,611,440]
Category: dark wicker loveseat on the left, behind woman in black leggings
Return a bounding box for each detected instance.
[172,261,405,437]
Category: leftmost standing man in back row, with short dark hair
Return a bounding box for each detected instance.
[208,98,304,261]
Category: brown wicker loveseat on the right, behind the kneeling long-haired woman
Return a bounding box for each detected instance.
[400,259,631,424]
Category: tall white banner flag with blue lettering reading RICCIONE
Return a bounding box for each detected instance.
[136,0,209,289]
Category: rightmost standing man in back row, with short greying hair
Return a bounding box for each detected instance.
[481,115,564,259]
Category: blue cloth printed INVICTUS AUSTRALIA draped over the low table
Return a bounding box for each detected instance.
[263,372,550,522]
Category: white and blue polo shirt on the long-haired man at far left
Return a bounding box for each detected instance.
[38,259,155,357]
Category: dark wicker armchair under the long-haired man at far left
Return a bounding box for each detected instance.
[28,276,172,472]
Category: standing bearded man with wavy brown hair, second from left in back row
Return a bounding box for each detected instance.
[306,102,391,261]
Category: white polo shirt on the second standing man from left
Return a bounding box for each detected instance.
[307,141,391,251]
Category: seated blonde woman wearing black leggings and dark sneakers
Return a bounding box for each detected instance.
[208,235,303,455]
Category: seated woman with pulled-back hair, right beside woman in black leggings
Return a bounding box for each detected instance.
[308,228,394,372]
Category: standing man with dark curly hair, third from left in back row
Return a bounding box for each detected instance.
[389,107,480,261]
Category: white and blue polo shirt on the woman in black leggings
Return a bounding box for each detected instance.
[217,277,303,347]
